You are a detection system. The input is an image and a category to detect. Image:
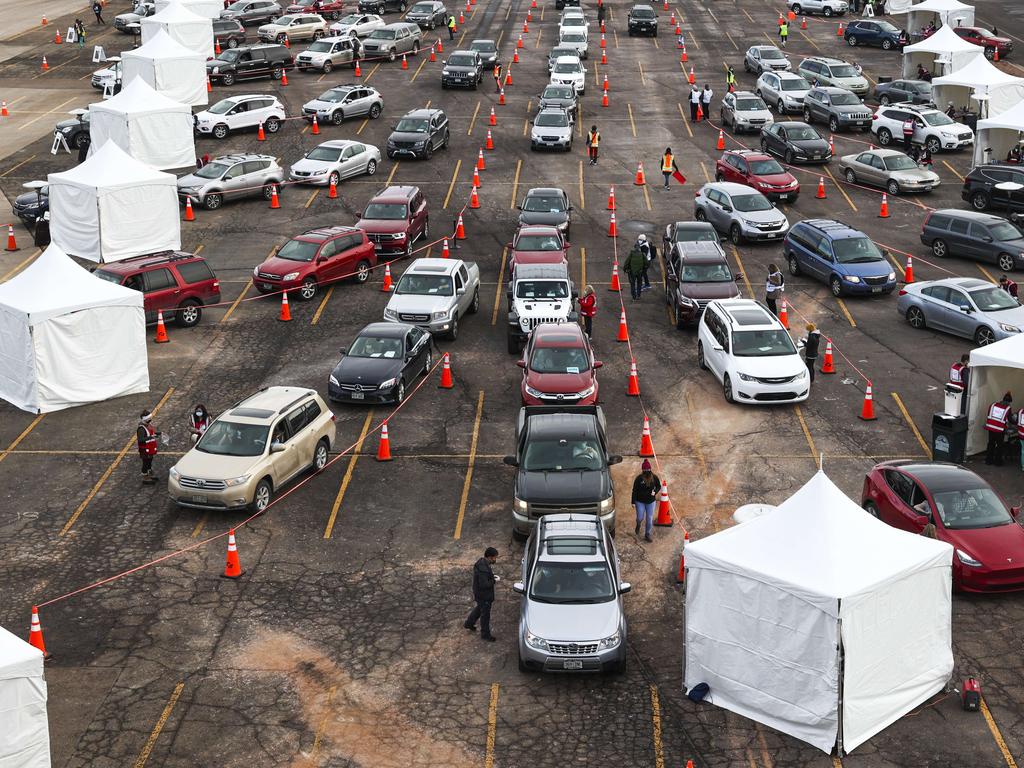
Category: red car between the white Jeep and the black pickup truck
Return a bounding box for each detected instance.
[516,323,604,406]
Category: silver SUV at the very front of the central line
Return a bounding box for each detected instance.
[512,514,633,672]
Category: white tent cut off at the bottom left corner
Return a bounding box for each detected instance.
[0,627,50,768]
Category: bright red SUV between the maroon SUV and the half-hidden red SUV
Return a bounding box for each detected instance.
[253,226,377,301]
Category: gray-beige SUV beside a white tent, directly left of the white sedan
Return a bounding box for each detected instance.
[178,155,285,211]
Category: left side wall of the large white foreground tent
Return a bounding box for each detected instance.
[684,567,839,753]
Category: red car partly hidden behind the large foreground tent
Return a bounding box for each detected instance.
[861,461,1024,592]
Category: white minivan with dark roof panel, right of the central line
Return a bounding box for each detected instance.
[697,299,811,403]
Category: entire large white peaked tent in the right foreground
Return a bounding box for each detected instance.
[684,471,953,753]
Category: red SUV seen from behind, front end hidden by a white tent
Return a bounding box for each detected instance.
[93,251,220,328]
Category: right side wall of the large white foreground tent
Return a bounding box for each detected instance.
[841,565,953,752]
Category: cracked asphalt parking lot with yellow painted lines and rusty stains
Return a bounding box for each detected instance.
[0,0,1024,768]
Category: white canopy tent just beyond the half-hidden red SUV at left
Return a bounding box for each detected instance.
[47,141,181,261]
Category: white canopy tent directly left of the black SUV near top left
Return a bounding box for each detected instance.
[120,30,210,107]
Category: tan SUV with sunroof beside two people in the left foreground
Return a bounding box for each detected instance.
[167,387,335,511]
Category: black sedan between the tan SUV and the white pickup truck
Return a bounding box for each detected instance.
[327,323,433,402]
